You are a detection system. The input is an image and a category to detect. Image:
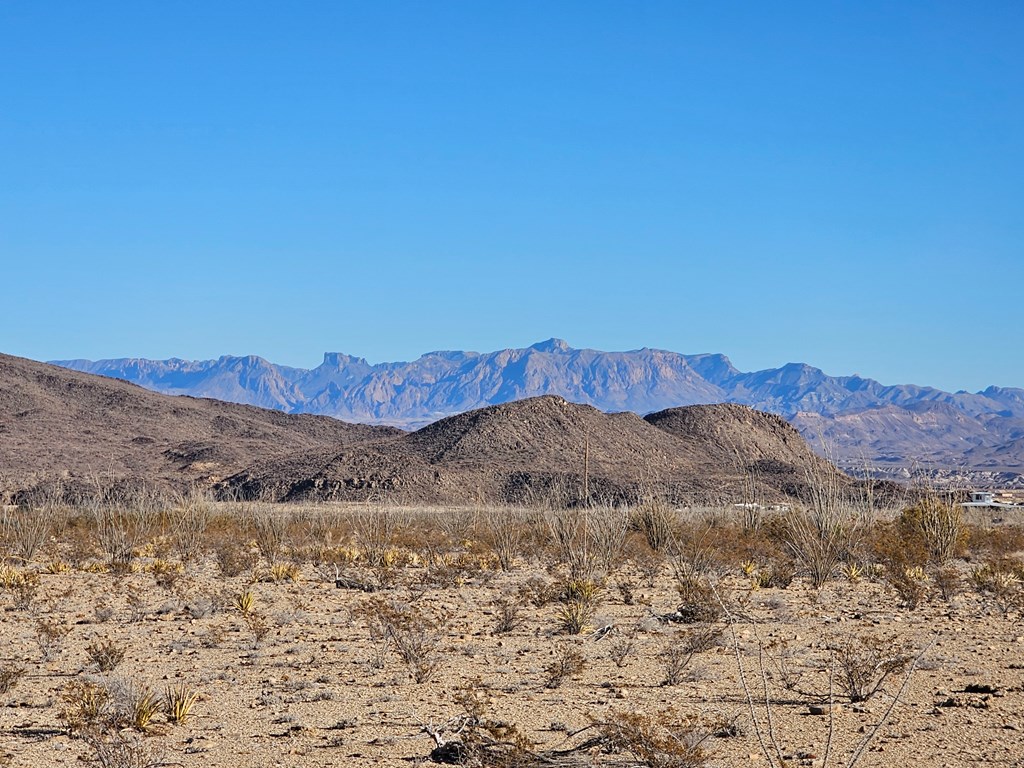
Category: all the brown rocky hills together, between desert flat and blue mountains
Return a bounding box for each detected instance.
[0,356,826,503]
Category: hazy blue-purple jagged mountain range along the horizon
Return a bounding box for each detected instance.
[52,339,1024,482]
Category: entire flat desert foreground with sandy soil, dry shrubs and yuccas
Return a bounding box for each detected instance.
[0,497,1024,767]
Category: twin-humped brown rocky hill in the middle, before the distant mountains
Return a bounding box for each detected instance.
[225,395,827,503]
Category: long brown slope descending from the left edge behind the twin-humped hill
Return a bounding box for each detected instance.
[0,354,401,499]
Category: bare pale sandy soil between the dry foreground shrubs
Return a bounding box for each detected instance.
[0,518,1024,767]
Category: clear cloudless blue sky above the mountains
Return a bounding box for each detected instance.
[0,0,1024,389]
